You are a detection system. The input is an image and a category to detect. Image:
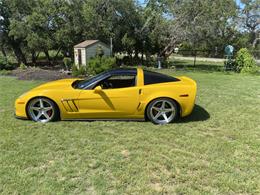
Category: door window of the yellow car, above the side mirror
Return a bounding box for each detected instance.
[97,75,136,89]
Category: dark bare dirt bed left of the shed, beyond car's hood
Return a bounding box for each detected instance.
[12,67,71,81]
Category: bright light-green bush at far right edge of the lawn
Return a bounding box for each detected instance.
[235,48,257,73]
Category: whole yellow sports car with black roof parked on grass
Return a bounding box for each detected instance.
[15,68,197,124]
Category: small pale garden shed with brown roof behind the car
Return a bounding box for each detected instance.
[74,40,111,67]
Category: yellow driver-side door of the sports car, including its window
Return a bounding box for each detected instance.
[78,75,139,118]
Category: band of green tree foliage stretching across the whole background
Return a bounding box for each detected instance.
[0,0,260,64]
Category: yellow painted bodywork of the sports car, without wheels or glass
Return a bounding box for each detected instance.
[15,68,197,120]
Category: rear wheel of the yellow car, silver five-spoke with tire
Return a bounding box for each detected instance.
[146,98,178,124]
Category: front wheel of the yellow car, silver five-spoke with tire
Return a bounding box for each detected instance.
[27,97,59,123]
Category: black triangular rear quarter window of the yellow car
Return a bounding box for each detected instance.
[144,70,179,85]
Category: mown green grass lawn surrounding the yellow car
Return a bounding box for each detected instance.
[0,70,260,194]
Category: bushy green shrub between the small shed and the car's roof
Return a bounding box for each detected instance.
[88,57,116,74]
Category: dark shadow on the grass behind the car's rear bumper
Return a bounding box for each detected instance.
[176,104,210,123]
